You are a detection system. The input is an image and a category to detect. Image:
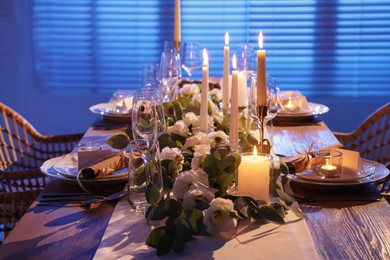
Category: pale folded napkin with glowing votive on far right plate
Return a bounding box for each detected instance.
[278,90,310,112]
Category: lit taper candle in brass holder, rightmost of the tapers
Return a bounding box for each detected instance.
[257,32,267,106]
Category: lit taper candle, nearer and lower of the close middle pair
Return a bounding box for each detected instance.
[229,55,238,150]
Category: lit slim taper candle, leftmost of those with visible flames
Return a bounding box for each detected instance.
[200,49,209,132]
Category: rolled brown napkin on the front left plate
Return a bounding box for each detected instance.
[80,153,129,179]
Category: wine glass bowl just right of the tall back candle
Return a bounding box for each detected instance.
[182,42,201,80]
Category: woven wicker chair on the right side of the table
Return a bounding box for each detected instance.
[333,102,390,191]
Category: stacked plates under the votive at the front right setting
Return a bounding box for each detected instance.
[287,159,389,188]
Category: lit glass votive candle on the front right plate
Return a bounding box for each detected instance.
[316,150,343,178]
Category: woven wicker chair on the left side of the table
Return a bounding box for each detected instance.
[0,102,82,244]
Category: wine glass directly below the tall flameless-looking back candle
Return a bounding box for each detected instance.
[160,52,182,102]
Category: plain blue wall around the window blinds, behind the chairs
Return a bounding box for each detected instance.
[0,0,390,135]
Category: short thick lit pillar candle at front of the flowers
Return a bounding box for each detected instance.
[238,147,271,201]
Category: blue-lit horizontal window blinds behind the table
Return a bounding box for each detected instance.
[32,0,390,98]
